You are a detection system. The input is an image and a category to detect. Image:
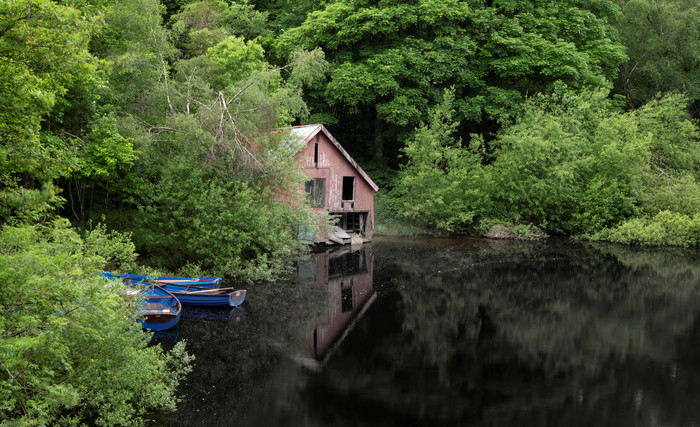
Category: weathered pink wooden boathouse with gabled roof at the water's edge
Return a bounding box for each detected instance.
[291,124,379,244]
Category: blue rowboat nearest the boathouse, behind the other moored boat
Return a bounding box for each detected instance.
[123,279,246,307]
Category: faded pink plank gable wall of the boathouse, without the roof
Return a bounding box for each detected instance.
[301,132,374,237]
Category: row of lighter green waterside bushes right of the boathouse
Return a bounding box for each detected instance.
[394,91,700,239]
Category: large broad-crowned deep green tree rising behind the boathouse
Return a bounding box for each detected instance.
[278,0,625,157]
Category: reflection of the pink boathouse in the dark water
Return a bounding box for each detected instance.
[299,245,377,369]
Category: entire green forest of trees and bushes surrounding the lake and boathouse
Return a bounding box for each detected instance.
[0,0,700,425]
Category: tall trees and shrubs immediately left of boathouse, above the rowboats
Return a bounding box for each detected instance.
[69,0,326,281]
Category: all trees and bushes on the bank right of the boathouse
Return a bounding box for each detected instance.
[277,0,700,245]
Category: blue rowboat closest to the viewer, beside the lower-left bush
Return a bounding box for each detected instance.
[126,283,182,331]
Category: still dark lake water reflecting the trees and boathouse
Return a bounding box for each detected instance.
[155,238,700,426]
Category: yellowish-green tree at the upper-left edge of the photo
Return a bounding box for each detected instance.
[0,0,99,226]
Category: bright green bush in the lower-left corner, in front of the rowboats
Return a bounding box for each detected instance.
[0,221,189,425]
